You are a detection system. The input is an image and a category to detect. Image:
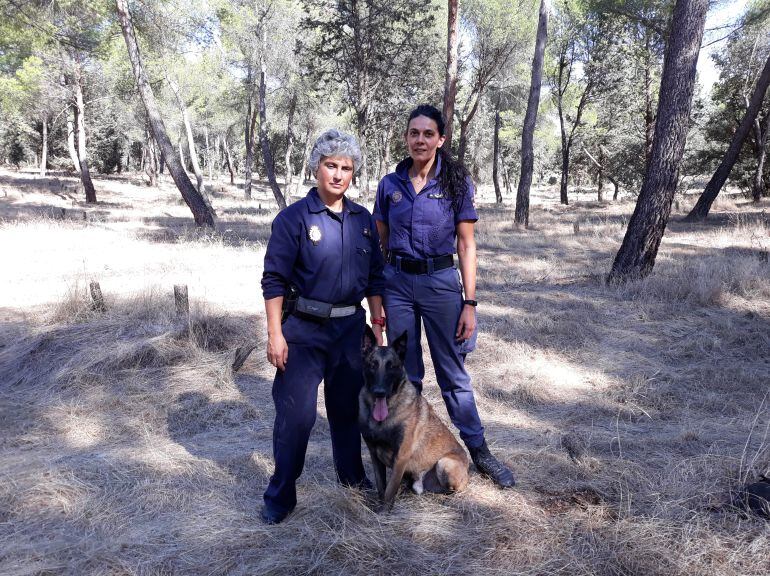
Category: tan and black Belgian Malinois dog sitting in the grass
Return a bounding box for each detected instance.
[358,326,469,510]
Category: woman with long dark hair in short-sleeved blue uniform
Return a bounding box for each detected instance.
[373,104,515,488]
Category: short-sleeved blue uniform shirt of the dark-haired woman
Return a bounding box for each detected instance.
[373,154,479,259]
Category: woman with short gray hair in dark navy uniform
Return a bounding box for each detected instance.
[261,129,385,524]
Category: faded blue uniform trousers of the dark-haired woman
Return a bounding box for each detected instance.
[384,264,484,448]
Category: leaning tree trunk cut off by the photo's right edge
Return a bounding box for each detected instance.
[685,57,770,222]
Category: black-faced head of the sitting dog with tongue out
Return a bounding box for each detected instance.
[361,326,407,422]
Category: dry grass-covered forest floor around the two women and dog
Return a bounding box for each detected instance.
[0,171,770,576]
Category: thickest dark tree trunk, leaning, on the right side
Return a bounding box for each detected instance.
[607,0,708,283]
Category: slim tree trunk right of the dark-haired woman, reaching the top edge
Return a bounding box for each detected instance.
[514,0,548,226]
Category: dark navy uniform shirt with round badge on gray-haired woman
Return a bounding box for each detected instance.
[262,188,385,305]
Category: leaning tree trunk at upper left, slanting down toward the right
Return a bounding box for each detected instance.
[115,0,215,227]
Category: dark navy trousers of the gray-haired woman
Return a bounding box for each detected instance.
[264,310,366,512]
